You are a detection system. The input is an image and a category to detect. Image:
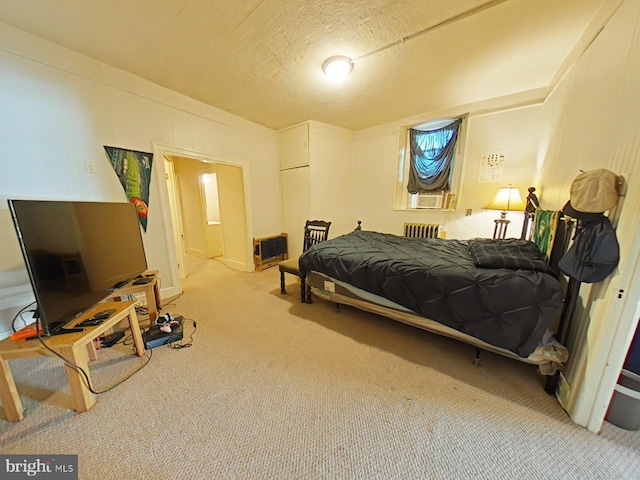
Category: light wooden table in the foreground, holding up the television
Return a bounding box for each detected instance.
[0,301,144,422]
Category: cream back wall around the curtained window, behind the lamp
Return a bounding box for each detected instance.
[353,104,546,239]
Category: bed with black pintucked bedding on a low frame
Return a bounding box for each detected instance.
[300,216,568,375]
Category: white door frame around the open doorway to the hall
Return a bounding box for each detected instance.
[153,142,253,278]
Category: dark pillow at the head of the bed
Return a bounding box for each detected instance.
[469,238,553,273]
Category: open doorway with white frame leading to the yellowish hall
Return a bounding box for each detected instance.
[155,144,253,279]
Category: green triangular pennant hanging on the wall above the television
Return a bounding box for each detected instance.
[104,145,153,232]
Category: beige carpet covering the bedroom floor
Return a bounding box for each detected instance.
[0,261,640,479]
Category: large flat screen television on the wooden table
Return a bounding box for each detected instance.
[8,200,147,336]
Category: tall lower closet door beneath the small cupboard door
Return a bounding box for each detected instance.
[280,166,311,257]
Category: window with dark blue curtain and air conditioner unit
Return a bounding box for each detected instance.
[394,118,466,209]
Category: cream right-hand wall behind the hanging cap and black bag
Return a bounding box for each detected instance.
[539,0,640,430]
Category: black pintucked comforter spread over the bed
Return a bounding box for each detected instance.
[300,231,562,357]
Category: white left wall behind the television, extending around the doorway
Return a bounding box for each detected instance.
[0,23,282,336]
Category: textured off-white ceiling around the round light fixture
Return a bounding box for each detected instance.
[0,0,606,129]
